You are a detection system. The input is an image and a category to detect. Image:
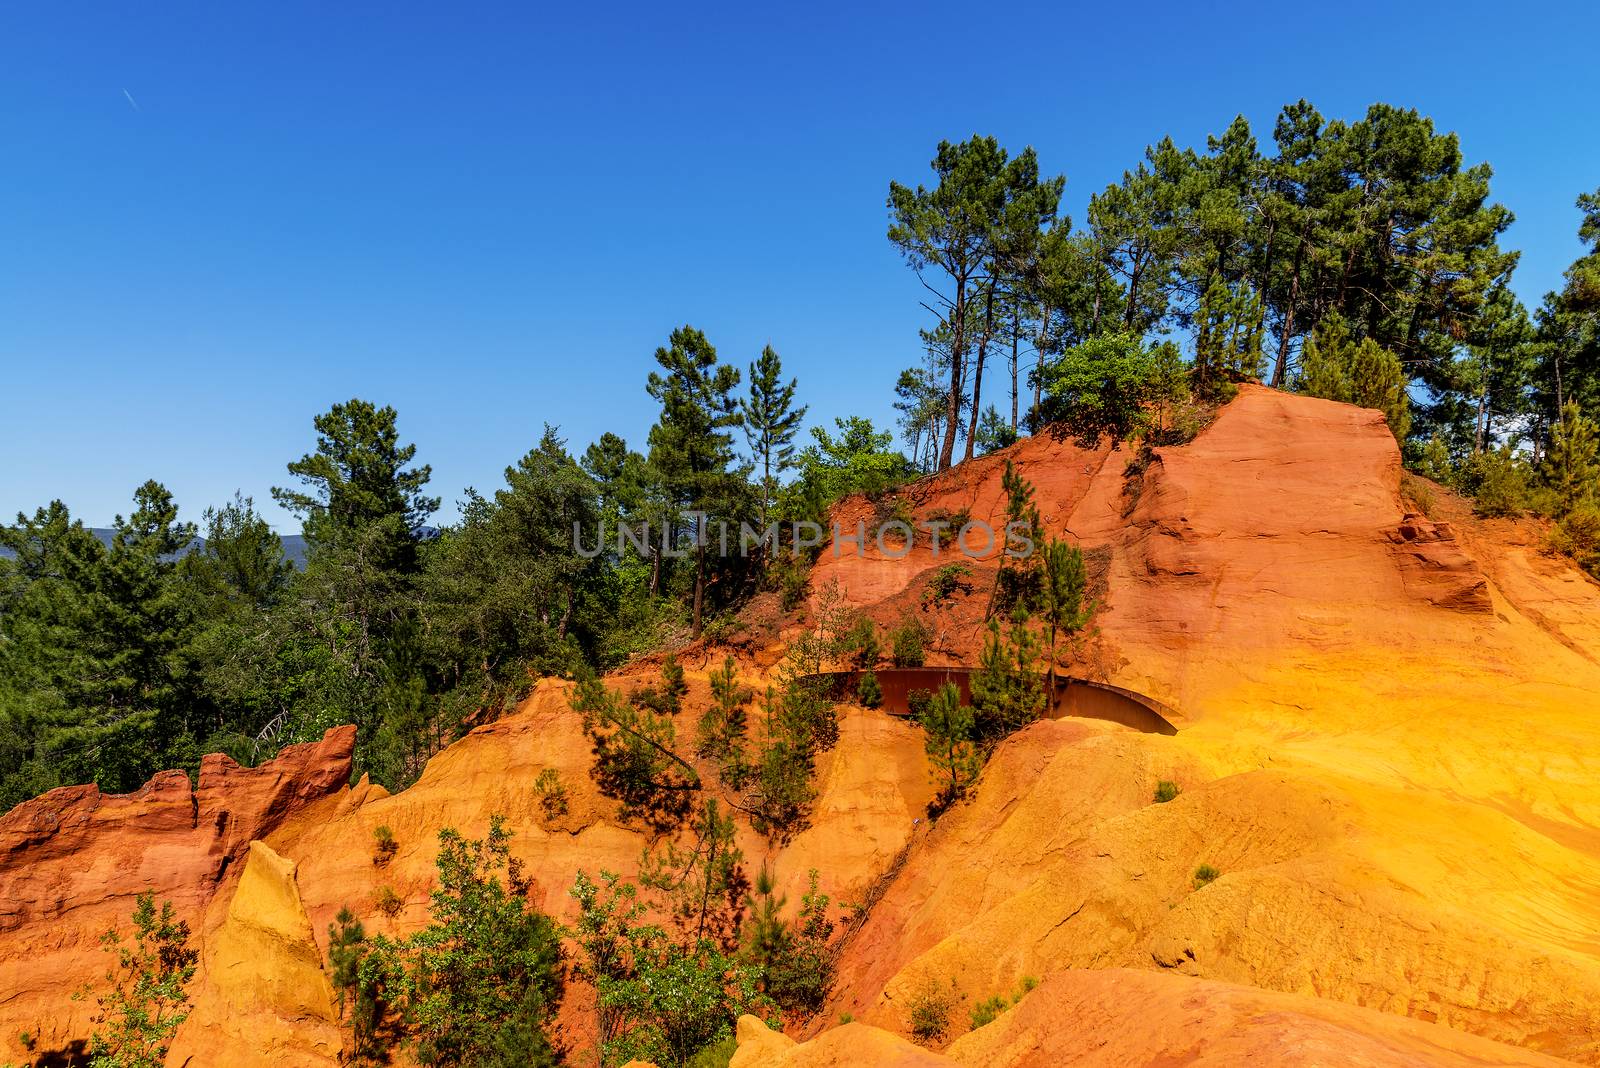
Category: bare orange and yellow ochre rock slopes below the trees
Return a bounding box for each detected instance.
[0,387,1600,1068]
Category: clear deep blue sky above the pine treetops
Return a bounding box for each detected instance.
[0,2,1600,529]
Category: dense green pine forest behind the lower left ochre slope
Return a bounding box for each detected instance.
[0,334,864,807]
